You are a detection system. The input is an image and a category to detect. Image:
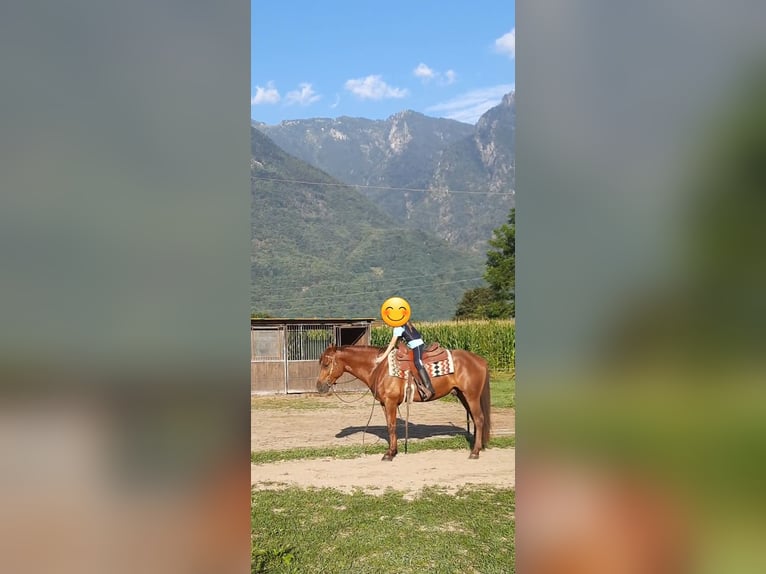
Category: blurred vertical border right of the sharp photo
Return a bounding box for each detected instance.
[516,0,766,574]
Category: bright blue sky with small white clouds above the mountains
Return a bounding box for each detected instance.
[250,0,516,124]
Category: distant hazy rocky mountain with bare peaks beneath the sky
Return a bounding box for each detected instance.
[254,93,516,254]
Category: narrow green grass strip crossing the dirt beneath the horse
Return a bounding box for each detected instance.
[250,436,516,464]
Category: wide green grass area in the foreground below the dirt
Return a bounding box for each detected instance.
[251,487,515,574]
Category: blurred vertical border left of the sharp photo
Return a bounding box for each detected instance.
[0,0,250,573]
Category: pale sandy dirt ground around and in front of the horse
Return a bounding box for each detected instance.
[251,393,516,494]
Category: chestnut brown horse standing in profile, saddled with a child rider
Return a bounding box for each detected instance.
[317,345,491,461]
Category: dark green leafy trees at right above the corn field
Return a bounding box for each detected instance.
[455,208,516,319]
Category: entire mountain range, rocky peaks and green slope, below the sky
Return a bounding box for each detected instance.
[251,94,515,320]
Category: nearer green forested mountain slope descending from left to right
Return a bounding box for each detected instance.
[250,124,484,320]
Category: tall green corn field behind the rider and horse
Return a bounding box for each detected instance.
[370,320,516,372]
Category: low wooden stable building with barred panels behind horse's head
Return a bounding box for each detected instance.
[250,318,377,395]
